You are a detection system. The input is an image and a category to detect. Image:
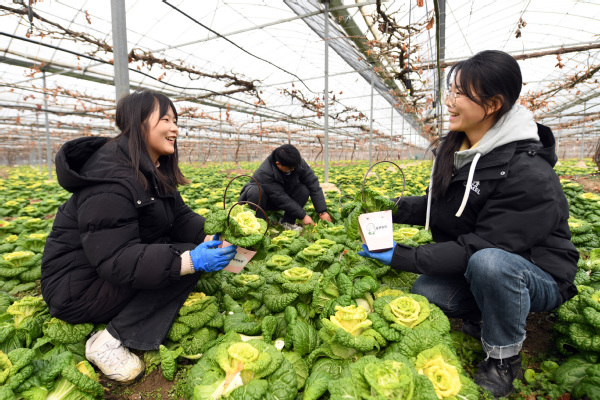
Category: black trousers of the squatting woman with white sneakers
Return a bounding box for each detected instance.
[53,273,202,350]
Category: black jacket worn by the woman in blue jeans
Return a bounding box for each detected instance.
[391,124,579,300]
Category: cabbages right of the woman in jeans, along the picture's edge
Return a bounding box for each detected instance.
[525,180,600,400]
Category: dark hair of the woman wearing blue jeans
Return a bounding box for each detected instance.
[430,50,523,199]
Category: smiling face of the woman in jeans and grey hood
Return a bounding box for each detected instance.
[446,71,499,145]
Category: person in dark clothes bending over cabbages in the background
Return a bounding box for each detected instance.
[239,144,331,231]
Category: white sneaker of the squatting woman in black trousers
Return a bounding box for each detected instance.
[85,329,144,382]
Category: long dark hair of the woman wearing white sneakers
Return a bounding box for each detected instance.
[114,89,188,193]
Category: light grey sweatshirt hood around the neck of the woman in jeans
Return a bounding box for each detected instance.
[454,104,540,170]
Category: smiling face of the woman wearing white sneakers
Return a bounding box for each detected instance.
[144,103,179,163]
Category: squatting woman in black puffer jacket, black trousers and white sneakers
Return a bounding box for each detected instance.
[41,90,236,382]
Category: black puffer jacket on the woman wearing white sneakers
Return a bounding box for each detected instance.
[41,137,205,315]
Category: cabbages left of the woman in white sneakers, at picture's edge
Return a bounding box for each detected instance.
[0,168,104,399]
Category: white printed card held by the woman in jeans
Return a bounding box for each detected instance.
[358,210,394,251]
